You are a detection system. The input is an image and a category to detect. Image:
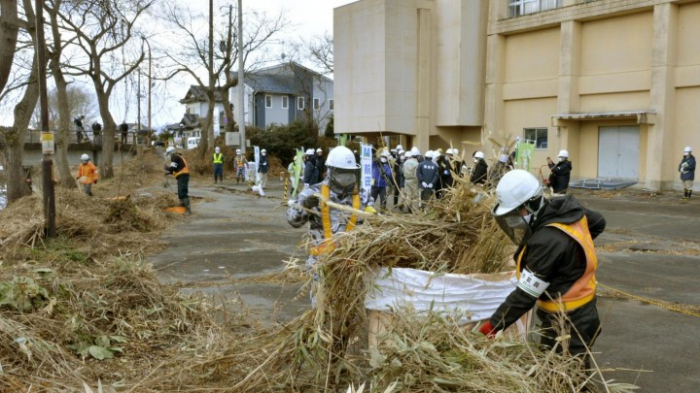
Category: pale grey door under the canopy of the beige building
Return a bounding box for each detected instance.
[598,126,639,180]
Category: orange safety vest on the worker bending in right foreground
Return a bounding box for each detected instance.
[516,216,598,312]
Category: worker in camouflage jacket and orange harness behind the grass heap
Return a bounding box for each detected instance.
[287,146,376,306]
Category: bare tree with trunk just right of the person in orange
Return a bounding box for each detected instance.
[59,0,155,178]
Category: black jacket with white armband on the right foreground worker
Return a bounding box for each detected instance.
[491,195,605,330]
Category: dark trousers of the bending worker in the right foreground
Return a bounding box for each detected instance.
[537,299,601,369]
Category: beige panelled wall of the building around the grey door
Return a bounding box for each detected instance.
[484,0,700,188]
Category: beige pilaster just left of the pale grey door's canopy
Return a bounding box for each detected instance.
[550,21,581,170]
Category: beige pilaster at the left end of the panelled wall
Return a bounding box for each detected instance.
[482,34,506,144]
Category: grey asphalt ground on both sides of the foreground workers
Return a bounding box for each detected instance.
[149,178,700,392]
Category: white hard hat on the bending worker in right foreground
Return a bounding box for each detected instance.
[493,169,542,216]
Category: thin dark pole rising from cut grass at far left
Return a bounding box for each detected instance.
[34,0,56,238]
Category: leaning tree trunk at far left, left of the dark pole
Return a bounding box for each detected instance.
[5,56,39,202]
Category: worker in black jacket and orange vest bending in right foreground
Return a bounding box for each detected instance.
[480,169,605,369]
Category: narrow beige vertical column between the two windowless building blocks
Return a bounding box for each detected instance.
[414,8,432,152]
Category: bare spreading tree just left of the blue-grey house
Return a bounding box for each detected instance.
[164,3,287,156]
